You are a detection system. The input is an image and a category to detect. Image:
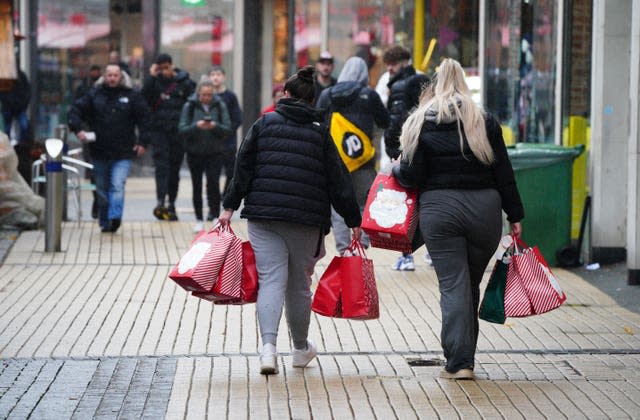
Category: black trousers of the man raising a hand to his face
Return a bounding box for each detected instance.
[151,127,184,204]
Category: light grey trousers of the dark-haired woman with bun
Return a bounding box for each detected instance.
[248,220,324,349]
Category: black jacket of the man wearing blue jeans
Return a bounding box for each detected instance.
[68,76,150,160]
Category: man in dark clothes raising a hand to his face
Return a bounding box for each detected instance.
[142,54,195,220]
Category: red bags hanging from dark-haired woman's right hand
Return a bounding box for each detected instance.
[311,241,380,320]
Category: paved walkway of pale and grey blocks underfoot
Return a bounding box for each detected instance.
[0,178,640,419]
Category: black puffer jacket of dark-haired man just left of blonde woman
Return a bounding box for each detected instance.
[384,66,429,159]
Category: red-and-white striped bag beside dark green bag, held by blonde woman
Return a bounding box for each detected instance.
[504,237,567,317]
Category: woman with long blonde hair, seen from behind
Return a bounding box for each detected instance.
[393,59,524,379]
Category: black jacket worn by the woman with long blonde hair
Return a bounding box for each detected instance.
[393,111,524,223]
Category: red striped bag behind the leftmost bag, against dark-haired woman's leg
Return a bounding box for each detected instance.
[192,228,258,305]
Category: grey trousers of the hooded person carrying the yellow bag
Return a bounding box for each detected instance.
[331,166,376,255]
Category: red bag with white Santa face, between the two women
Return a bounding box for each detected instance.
[361,173,418,253]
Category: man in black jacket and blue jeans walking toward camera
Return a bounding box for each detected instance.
[69,64,149,233]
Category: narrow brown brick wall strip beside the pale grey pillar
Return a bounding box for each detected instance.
[569,0,593,115]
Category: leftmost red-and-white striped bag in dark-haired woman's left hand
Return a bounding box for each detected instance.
[169,225,234,292]
